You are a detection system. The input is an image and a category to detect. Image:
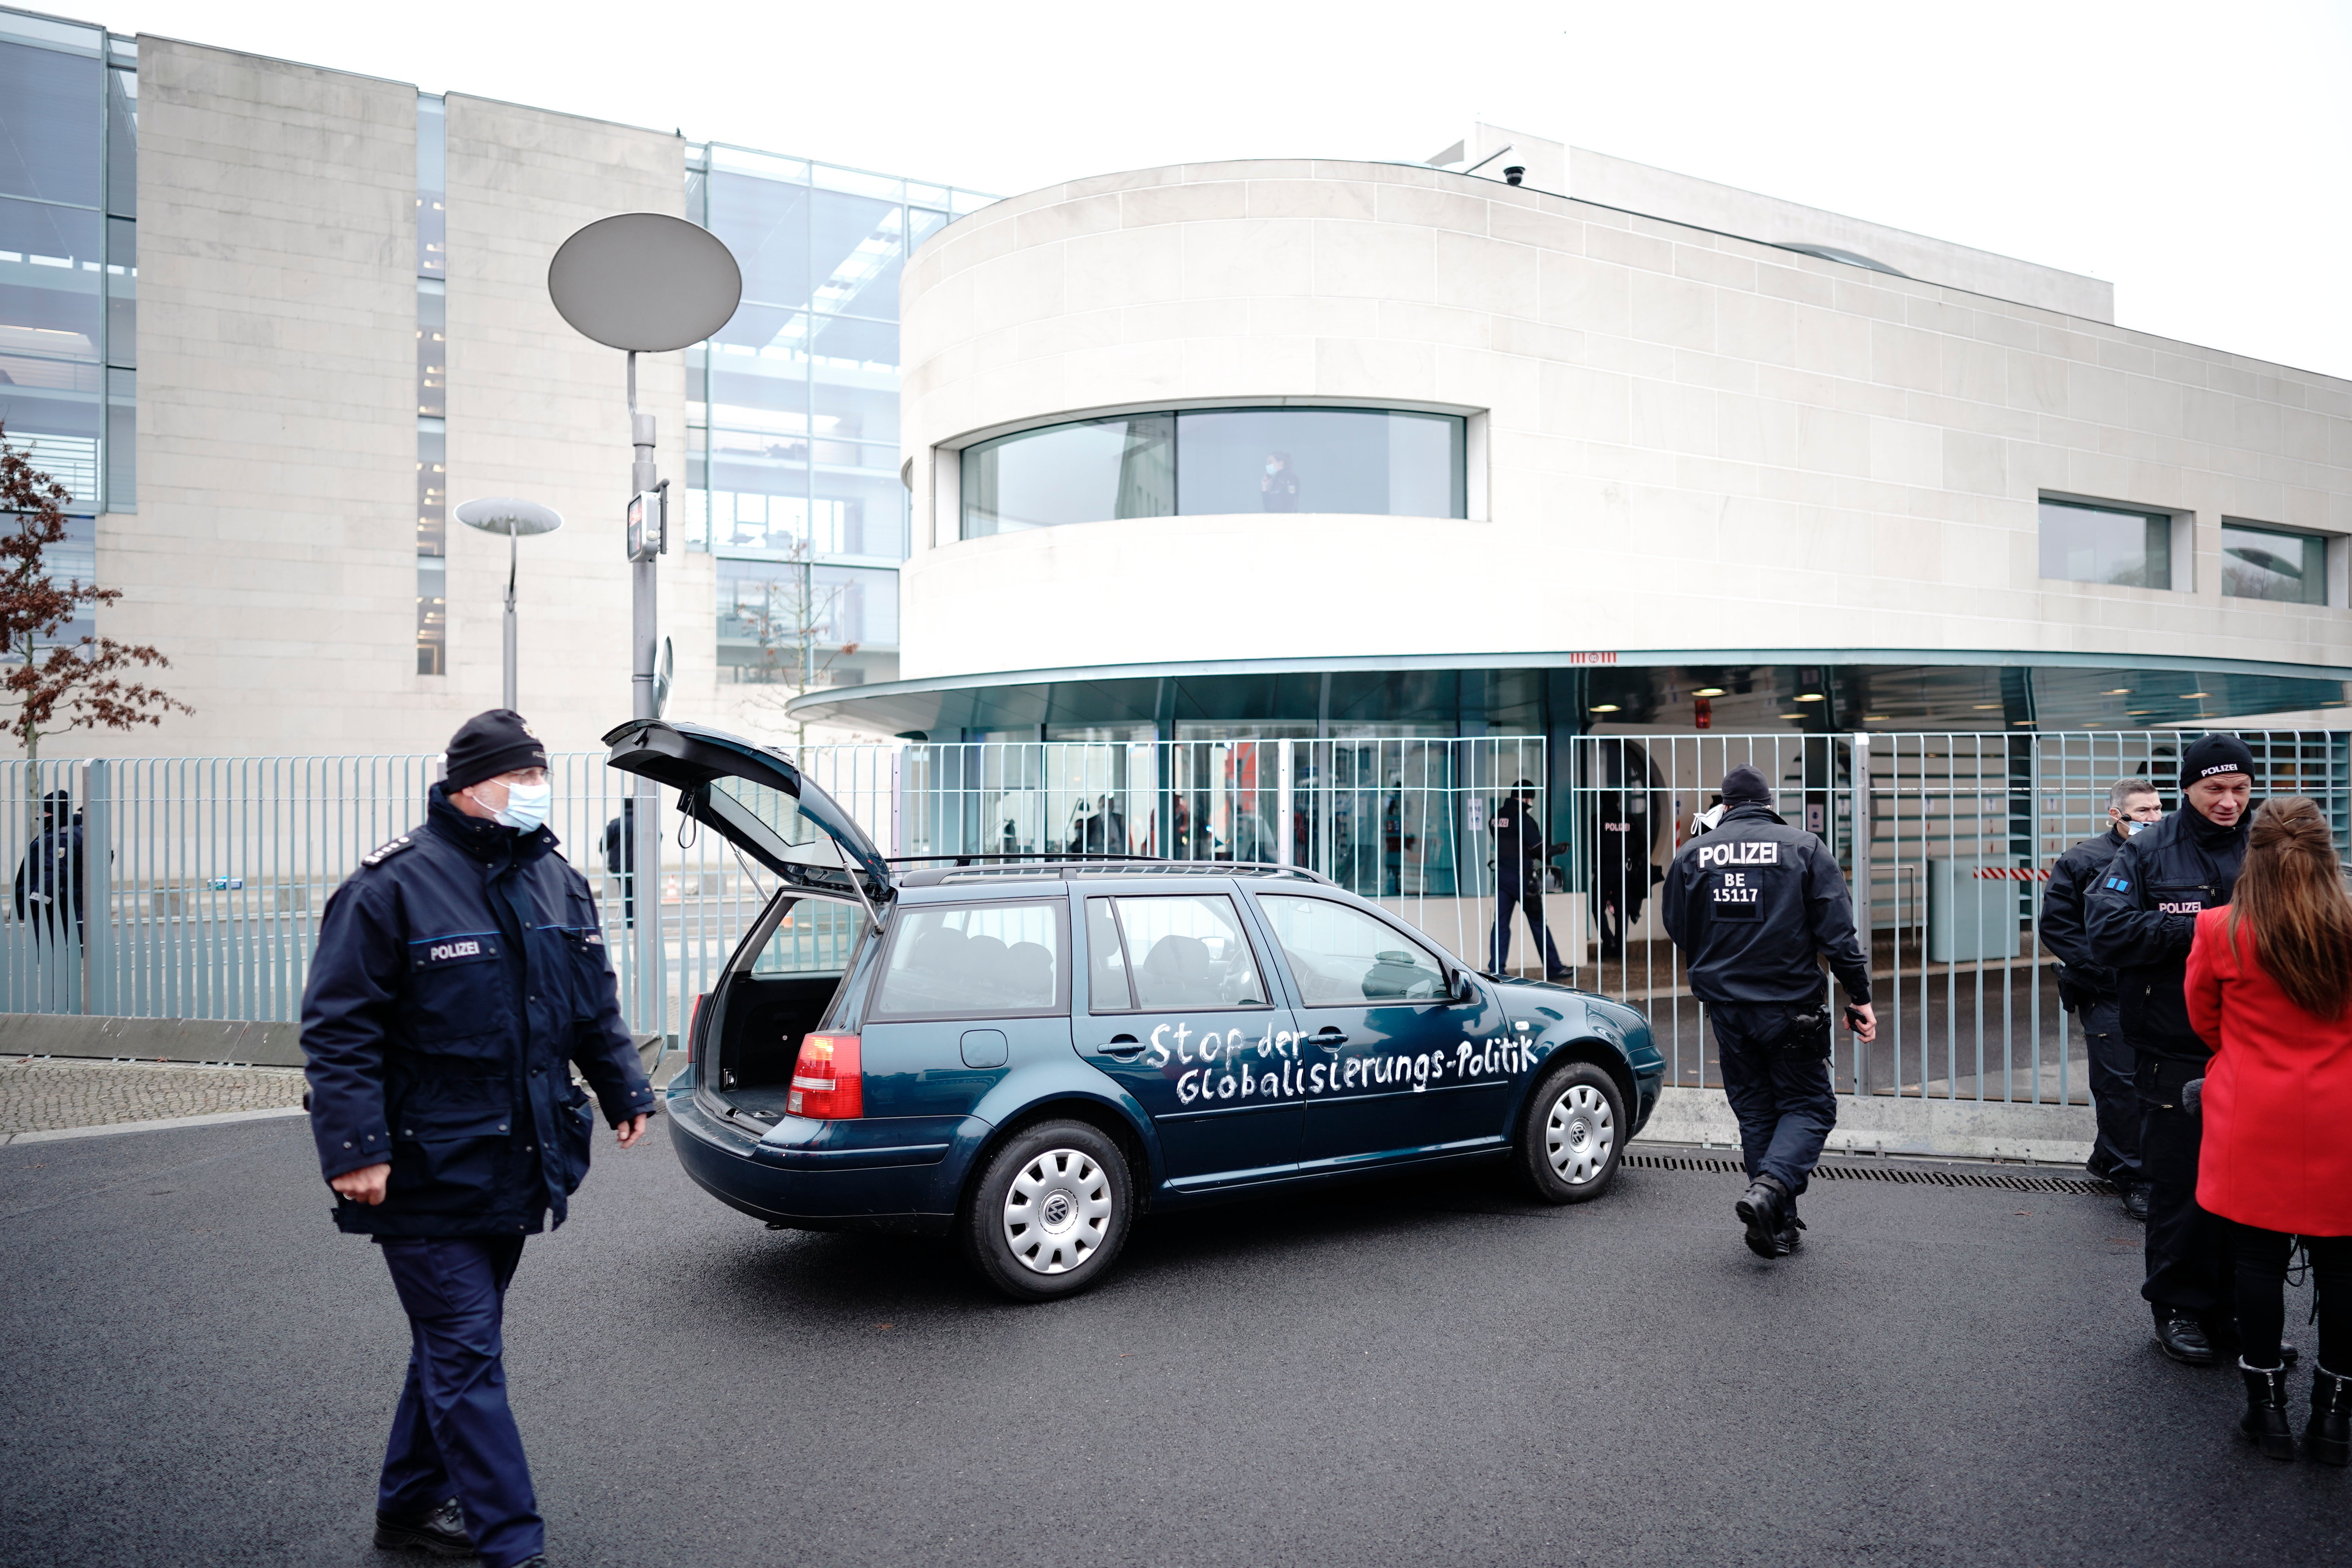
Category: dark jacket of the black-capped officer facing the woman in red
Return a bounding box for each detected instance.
[2089,804,2253,1063]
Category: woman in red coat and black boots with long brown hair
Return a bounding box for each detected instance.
[2187,797,2352,1465]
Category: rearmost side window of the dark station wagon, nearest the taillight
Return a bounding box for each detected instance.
[868,898,1070,1020]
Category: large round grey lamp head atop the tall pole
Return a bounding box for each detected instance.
[548,212,743,353]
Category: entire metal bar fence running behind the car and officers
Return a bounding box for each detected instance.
[0,731,2352,1103]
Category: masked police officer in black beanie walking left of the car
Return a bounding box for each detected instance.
[301,708,654,1568]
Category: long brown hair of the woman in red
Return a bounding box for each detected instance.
[2230,795,2352,1020]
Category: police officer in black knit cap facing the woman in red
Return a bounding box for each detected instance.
[2089,736,2253,1366]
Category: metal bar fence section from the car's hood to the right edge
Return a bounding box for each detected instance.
[1564,731,2352,1105]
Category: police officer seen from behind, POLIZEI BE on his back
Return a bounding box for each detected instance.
[1663,766,1877,1258]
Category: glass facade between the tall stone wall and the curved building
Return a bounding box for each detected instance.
[682,146,993,686]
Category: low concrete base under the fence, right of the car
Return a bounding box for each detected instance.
[1637,1089,2098,1166]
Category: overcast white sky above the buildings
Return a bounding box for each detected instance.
[92,0,2352,376]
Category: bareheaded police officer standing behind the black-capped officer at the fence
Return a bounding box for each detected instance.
[2042,778,2164,1220]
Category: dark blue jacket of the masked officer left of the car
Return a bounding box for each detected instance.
[301,785,654,1236]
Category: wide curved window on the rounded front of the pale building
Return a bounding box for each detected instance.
[962,409,1468,538]
